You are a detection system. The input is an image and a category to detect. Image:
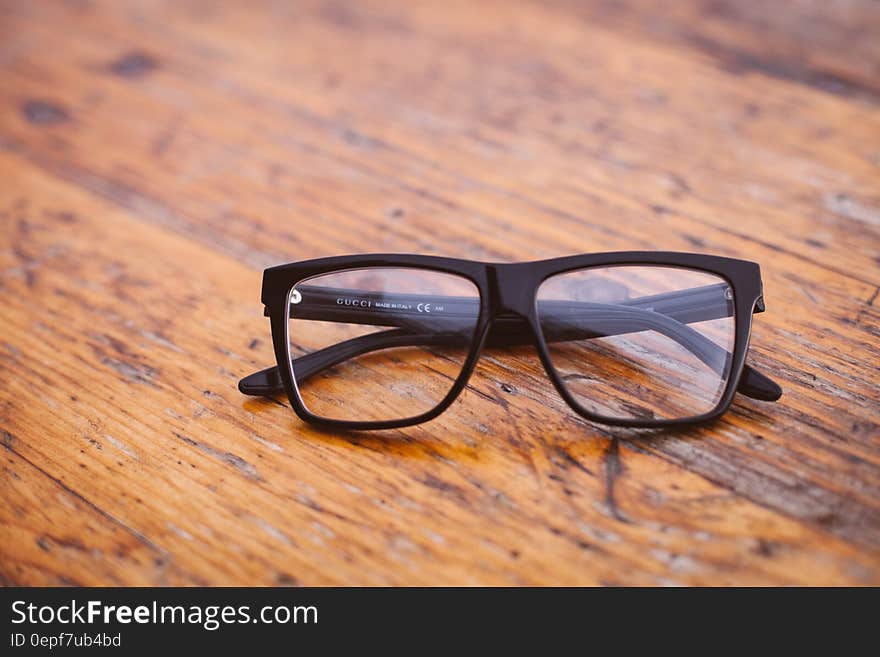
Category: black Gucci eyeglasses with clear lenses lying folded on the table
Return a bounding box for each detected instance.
[238,252,782,429]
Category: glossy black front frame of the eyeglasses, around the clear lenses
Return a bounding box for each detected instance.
[246,251,782,430]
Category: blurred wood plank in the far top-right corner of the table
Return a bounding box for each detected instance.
[548,0,880,102]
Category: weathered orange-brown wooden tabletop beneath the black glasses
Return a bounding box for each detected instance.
[0,0,880,585]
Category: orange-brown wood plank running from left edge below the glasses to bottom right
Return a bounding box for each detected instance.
[0,157,877,583]
